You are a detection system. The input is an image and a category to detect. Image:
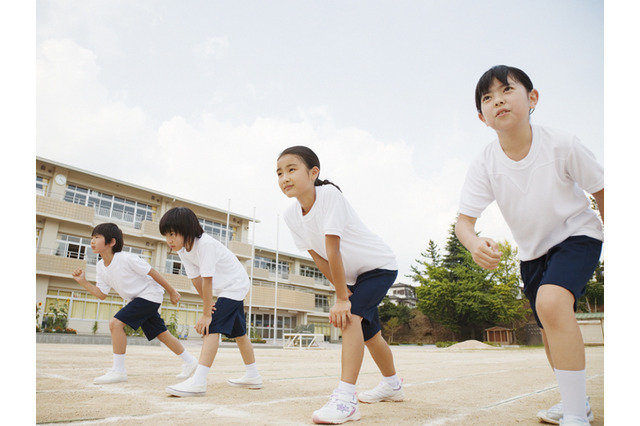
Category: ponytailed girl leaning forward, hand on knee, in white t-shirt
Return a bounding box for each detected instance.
[277,146,404,424]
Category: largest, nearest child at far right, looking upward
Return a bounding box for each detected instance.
[456,65,604,425]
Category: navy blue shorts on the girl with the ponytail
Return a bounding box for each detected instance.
[348,269,398,342]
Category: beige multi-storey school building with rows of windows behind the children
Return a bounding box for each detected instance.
[36,157,340,342]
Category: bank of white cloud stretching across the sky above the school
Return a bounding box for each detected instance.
[37,19,520,282]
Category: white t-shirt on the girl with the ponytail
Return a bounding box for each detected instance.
[283,185,398,284]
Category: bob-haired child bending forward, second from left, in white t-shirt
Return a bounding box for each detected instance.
[160,207,262,397]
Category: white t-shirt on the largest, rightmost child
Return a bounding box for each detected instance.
[459,125,604,261]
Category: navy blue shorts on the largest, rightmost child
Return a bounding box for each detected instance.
[520,235,602,328]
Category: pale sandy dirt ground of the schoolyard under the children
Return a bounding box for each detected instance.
[36,341,604,426]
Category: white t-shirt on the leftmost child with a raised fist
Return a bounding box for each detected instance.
[96,252,164,303]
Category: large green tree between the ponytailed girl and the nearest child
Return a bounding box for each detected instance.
[411,225,526,339]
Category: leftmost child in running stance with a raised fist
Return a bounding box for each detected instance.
[72,223,198,384]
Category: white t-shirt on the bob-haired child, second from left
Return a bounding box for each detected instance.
[178,233,250,301]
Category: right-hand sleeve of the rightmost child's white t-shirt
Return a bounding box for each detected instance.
[565,137,604,194]
